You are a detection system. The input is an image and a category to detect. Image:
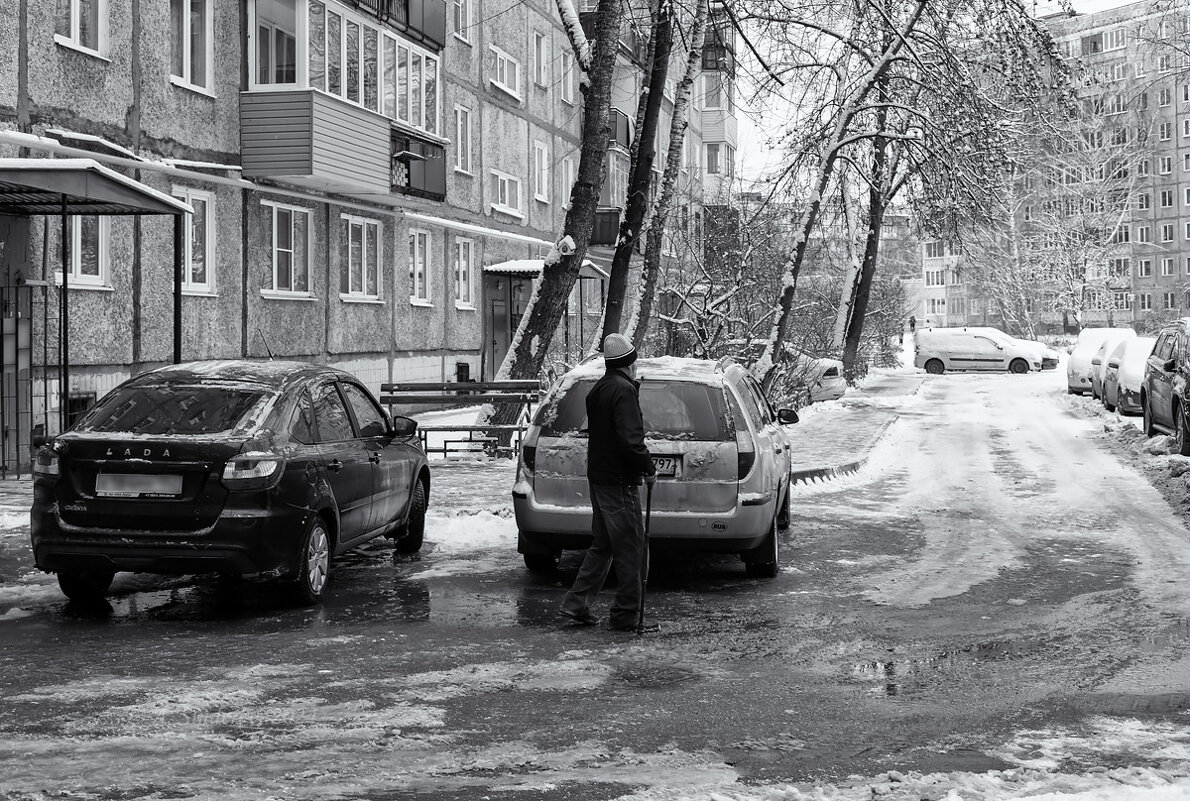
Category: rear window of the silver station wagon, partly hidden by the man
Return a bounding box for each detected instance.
[538,381,735,442]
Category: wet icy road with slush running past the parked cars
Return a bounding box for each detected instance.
[0,371,1190,801]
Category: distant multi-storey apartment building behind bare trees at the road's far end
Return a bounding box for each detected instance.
[922,2,1190,330]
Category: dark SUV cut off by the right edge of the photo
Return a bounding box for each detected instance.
[1140,317,1190,456]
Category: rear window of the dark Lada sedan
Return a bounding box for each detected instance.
[77,384,264,434]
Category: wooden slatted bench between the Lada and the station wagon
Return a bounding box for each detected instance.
[380,381,541,457]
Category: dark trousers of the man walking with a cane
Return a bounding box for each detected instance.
[562,484,645,626]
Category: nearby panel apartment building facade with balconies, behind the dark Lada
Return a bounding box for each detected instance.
[0,0,723,461]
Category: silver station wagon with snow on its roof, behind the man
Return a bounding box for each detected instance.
[513,356,797,578]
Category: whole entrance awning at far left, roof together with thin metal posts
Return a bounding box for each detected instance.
[0,158,194,428]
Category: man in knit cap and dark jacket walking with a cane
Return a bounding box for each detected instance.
[562,333,657,631]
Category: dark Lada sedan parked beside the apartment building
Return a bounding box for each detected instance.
[32,361,430,603]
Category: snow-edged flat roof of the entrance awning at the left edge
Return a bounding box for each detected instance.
[0,158,193,217]
